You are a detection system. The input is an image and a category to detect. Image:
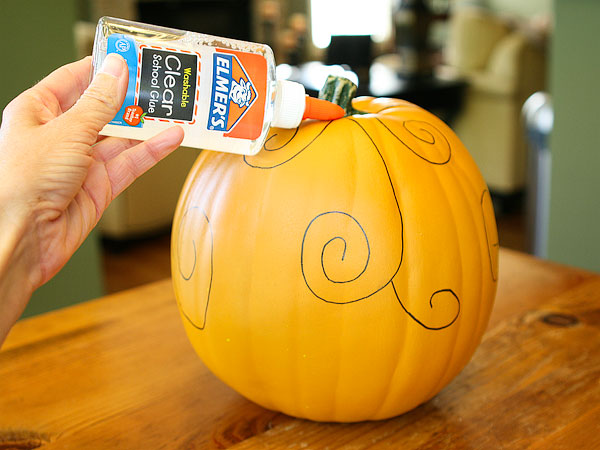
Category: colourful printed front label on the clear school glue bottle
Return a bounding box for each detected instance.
[107,33,267,140]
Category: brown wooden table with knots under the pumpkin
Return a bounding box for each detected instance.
[0,250,600,449]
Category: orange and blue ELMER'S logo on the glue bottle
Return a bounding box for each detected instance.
[207,50,266,139]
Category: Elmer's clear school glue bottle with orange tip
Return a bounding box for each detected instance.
[93,17,344,155]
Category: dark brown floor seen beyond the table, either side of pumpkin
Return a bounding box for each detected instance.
[103,210,526,293]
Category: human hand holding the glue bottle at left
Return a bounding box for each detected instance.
[0,54,183,343]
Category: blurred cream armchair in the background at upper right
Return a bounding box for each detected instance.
[446,9,545,195]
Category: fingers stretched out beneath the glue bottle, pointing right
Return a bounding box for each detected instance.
[105,126,183,200]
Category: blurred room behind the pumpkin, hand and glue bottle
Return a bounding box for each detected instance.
[0,0,600,315]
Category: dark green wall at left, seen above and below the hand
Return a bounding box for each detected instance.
[0,0,103,315]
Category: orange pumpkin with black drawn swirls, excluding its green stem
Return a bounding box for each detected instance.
[171,79,498,422]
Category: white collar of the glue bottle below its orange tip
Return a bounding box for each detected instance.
[271,80,306,128]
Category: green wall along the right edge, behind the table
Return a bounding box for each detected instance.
[548,0,600,271]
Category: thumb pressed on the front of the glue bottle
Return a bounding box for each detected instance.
[60,53,129,145]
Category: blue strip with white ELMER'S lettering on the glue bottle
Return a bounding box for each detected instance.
[208,52,233,131]
